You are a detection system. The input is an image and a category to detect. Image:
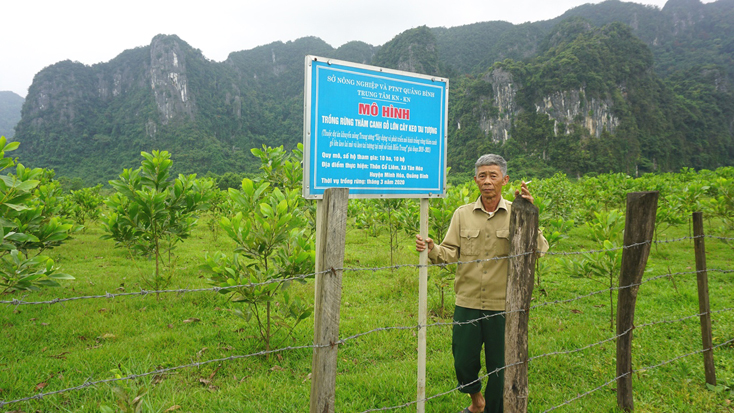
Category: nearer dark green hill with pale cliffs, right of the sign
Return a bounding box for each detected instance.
[449,18,734,175]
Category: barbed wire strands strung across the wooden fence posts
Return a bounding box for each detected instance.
[0,235,734,413]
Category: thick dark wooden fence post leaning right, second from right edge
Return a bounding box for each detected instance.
[617,191,658,411]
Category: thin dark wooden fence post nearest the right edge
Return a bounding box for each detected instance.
[693,212,716,386]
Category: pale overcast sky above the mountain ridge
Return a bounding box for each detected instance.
[0,0,711,97]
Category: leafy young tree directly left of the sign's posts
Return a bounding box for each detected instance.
[201,146,315,350]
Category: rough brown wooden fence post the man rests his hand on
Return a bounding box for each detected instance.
[506,197,538,413]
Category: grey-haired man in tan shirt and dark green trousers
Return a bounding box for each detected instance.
[415,154,548,413]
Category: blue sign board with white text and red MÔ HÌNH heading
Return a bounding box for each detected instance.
[303,56,449,198]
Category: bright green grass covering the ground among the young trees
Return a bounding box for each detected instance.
[0,214,734,412]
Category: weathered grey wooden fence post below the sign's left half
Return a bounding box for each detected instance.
[310,188,349,413]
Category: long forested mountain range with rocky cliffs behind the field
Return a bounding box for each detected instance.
[15,0,734,184]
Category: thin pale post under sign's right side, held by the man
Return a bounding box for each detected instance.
[416,198,428,413]
